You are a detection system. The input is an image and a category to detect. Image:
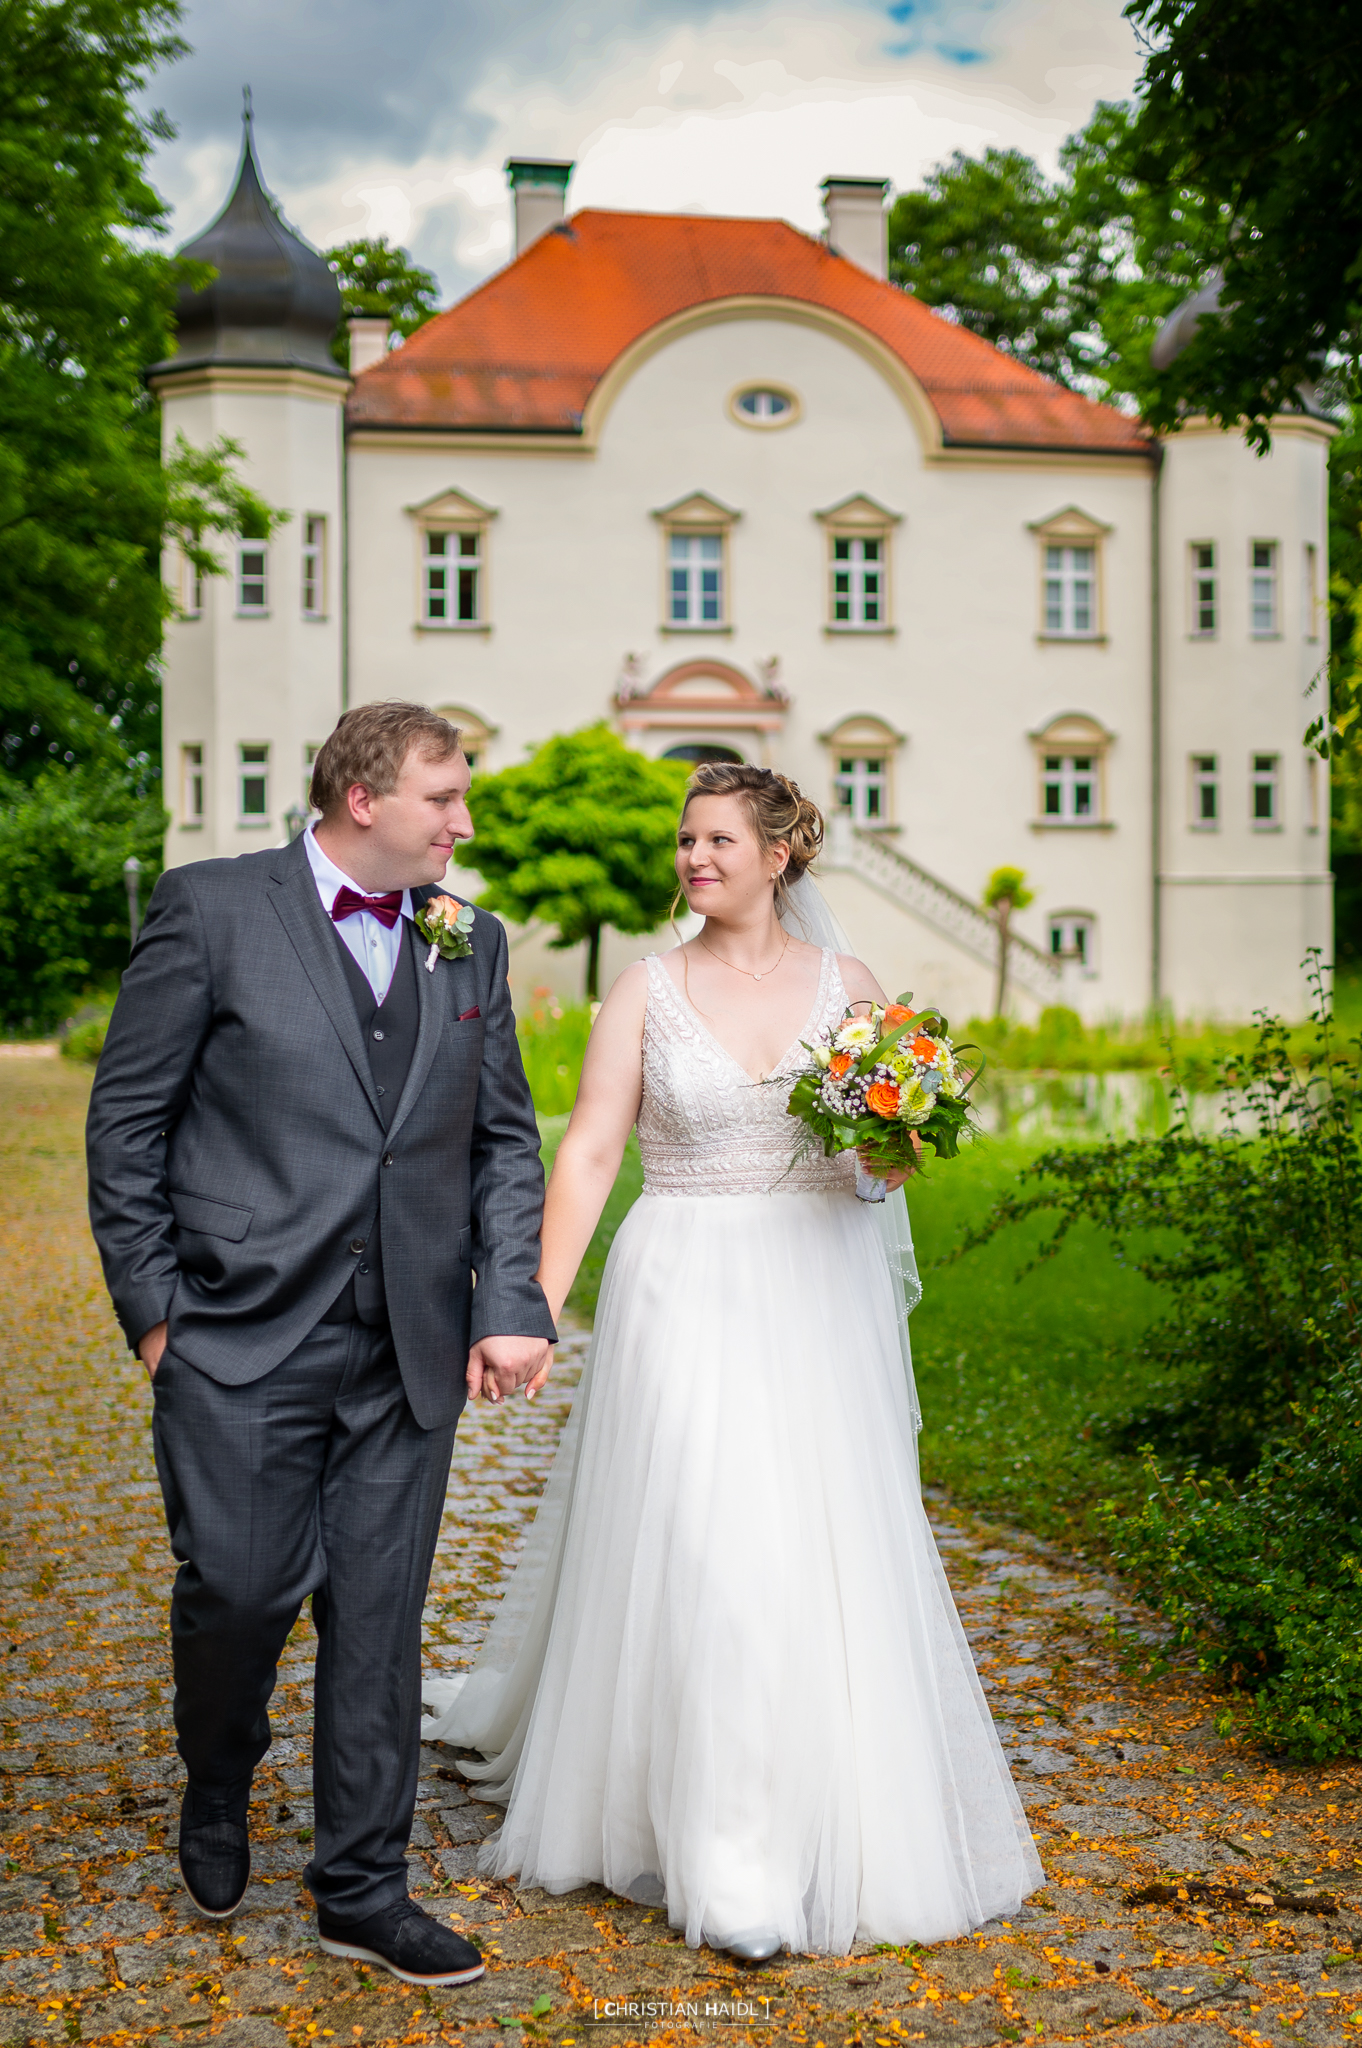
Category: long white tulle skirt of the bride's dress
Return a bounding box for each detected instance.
[424,1192,1042,1954]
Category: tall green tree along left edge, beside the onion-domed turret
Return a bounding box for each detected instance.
[0,0,274,1028]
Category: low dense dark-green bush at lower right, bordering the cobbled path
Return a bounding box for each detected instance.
[1106,1384,1362,1763]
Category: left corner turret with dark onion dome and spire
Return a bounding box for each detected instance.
[147,102,350,866]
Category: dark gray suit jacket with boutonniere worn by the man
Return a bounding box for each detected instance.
[86,840,553,1430]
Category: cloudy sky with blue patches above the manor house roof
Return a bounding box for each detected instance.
[140,0,1139,301]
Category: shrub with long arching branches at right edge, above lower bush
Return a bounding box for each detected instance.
[963,958,1362,1477]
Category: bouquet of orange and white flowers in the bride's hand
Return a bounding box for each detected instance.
[789,995,983,1169]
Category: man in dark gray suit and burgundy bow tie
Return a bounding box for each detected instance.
[88,702,553,1985]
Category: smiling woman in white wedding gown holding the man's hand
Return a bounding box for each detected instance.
[422,764,1042,1960]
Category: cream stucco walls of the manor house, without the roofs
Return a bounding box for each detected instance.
[162,159,1331,1018]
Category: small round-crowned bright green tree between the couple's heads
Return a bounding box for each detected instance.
[455,725,686,1001]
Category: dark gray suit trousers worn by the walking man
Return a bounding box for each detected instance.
[154,1323,455,1921]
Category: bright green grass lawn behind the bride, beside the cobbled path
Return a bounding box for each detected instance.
[543,1116,1159,1546]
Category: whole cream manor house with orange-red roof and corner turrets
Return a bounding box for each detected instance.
[150,119,1331,1020]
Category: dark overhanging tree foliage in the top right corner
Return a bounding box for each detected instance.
[1126,0,1362,446]
